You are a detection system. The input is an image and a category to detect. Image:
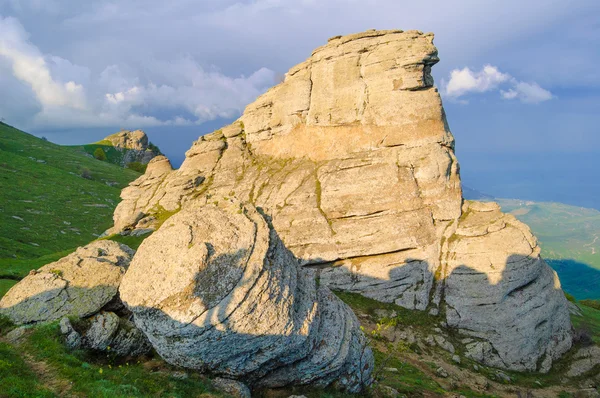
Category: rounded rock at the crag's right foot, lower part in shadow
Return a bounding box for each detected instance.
[438,202,572,371]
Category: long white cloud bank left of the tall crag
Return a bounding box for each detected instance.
[0,17,275,128]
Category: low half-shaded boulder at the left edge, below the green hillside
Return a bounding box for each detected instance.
[0,240,134,325]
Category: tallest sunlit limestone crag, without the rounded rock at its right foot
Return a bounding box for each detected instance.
[113,31,461,309]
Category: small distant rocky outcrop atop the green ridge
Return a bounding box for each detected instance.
[101,130,160,167]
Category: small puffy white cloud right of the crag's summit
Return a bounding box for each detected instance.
[442,65,553,104]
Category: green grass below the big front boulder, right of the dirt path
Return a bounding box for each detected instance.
[14,323,221,398]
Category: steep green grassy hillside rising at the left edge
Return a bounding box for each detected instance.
[0,123,139,295]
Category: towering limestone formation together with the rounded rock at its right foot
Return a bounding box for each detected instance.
[106,31,571,370]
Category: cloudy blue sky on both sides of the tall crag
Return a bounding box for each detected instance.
[0,0,600,209]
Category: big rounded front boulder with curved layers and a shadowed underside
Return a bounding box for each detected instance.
[120,201,373,392]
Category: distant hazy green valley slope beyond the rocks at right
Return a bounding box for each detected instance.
[496,199,600,299]
